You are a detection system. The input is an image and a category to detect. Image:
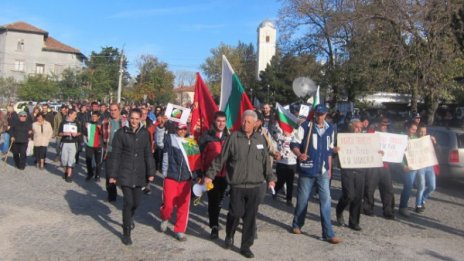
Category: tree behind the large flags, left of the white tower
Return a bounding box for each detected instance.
[201,42,256,97]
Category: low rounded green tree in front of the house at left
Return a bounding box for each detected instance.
[18,75,59,101]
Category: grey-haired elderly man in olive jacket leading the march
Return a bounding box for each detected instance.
[205,110,277,258]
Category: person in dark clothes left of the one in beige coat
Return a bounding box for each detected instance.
[10,111,32,170]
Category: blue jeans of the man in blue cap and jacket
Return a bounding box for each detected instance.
[292,172,335,239]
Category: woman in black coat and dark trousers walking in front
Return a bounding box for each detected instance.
[107,109,155,245]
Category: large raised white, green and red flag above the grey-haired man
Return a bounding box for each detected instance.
[219,55,254,131]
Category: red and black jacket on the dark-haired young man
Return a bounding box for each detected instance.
[199,130,229,177]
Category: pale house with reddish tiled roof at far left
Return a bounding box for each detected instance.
[0,22,86,81]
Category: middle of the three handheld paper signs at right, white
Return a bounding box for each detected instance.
[376,132,408,163]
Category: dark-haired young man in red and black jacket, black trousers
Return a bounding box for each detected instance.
[199,111,229,239]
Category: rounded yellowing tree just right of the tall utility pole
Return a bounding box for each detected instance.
[132,55,175,104]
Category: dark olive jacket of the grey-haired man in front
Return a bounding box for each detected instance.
[206,131,277,188]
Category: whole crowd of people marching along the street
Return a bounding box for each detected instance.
[0,102,437,258]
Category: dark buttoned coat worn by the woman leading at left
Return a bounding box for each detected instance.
[107,124,155,187]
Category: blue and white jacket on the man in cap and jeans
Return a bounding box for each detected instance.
[290,121,334,176]
